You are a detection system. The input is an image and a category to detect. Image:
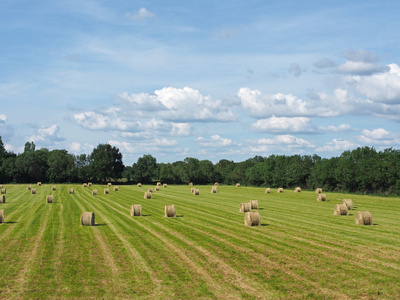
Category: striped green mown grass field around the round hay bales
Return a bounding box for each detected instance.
[0,185,400,299]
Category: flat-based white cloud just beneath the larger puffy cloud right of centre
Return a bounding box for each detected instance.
[252,116,315,132]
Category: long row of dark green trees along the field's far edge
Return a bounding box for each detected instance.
[0,137,400,195]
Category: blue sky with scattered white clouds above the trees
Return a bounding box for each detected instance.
[0,0,400,165]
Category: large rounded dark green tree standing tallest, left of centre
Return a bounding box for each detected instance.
[89,144,124,182]
